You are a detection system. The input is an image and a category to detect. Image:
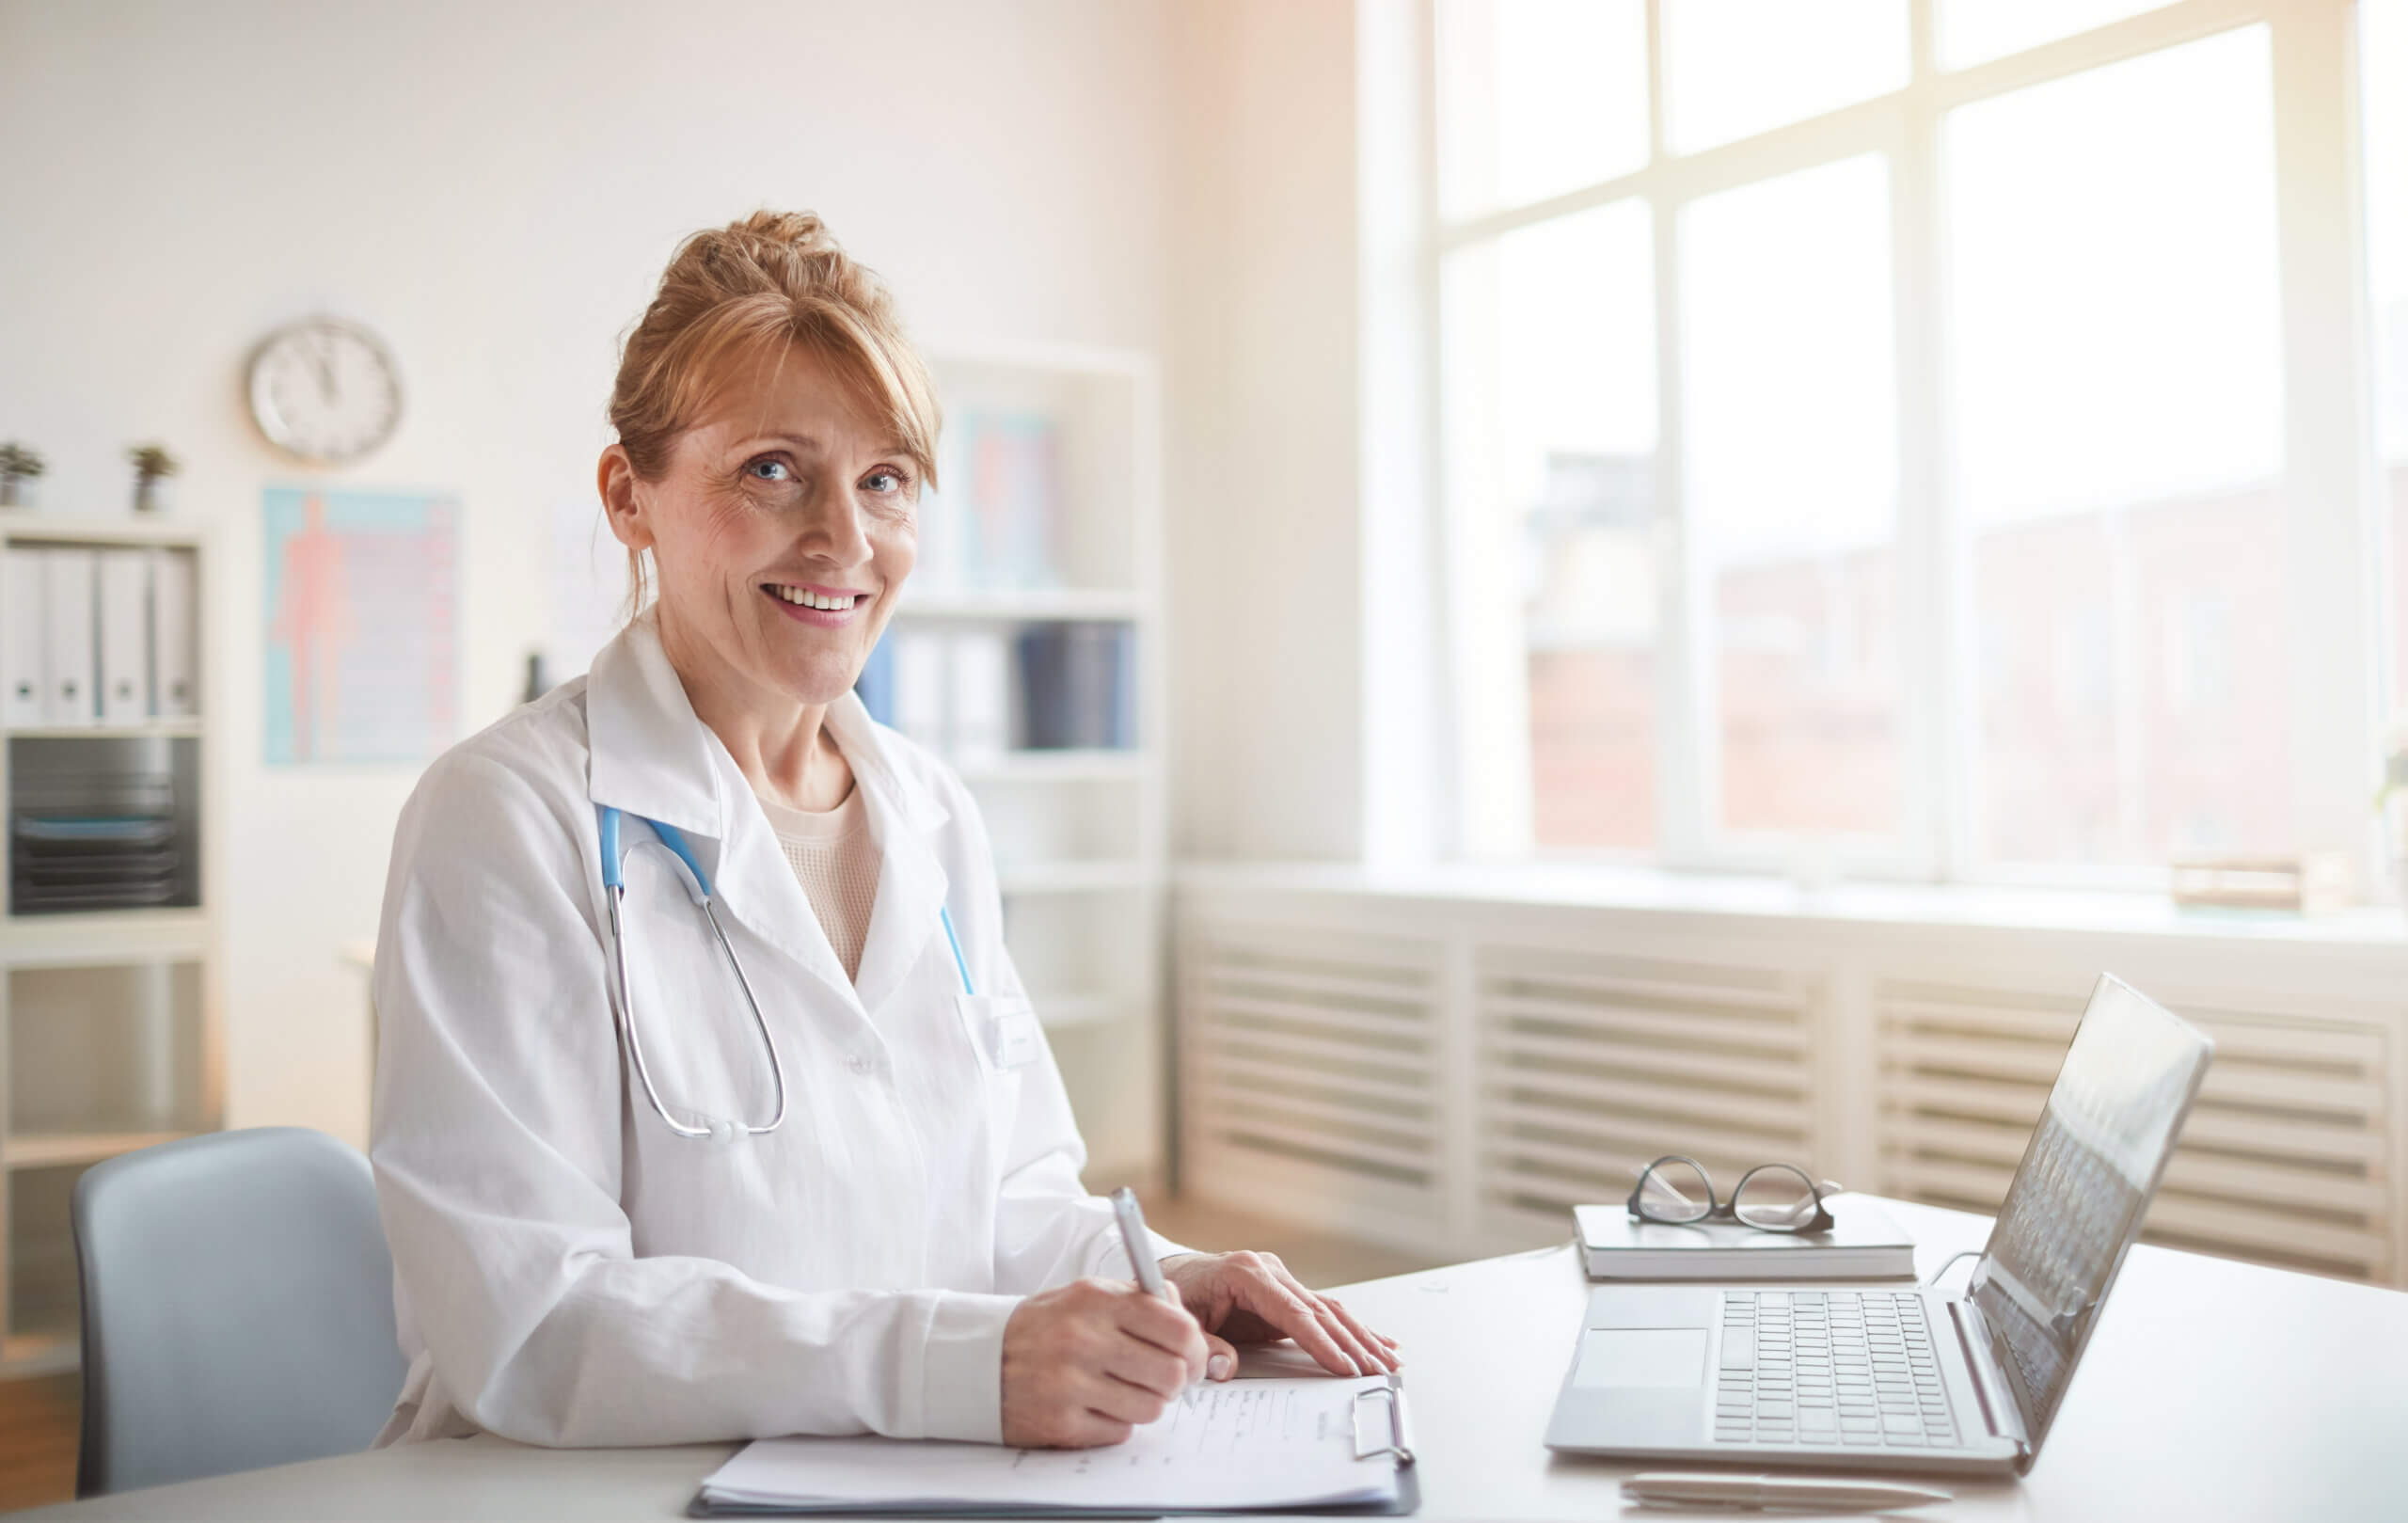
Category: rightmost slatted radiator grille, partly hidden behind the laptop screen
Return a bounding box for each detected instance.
[1876,981,2399,1279]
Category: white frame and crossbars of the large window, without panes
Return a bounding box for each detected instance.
[1420,0,2391,889]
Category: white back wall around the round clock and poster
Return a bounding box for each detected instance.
[0,0,1170,1140]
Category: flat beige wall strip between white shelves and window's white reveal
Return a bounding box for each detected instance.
[1168,0,1363,858]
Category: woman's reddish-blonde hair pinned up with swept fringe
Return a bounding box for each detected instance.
[610,212,944,610]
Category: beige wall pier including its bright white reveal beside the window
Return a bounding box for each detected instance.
[1170,0,1452,863]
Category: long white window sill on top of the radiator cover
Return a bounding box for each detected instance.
[1175,861,2408,947]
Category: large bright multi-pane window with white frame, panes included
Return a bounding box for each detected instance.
[1433,0,2408,882]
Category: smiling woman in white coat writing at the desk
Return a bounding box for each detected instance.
[371,212,1397,1446]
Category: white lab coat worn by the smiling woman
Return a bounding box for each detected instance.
[371,619,1178,1446]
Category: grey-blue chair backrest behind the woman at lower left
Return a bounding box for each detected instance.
[74,1125,404,1497]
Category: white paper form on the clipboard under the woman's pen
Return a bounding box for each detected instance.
[704,1376,1399,1511]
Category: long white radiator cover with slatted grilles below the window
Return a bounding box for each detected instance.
[1175,870,2408,1284]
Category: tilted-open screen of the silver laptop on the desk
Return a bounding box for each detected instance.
[1972,978,2215,1453]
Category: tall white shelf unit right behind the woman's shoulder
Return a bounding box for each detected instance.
[894,349,1168,1185]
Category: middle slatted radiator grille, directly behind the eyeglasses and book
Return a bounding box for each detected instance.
[1474,947,1814,1244]
